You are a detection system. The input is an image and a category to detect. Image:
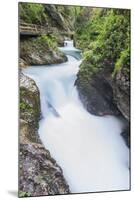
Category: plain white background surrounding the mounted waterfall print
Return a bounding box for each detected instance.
[0,0,134,200]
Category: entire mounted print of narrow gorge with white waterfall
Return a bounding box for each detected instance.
[19,3,130,197]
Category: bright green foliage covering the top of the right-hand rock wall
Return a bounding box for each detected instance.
[76,8,130,79]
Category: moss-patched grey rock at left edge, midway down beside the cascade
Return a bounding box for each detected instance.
[20,73,41,140]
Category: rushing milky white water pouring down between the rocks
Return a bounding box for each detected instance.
[24,42,129,193]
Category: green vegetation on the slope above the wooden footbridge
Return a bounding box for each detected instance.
[19,2,79,30]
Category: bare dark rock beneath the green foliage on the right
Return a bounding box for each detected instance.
[75,65,130,146]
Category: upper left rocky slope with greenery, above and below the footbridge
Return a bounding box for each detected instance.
[19,2,75,66]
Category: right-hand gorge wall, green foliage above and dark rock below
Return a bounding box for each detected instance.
[75,8,130,146]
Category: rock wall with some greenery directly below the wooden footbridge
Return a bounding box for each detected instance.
[20,36,67,66]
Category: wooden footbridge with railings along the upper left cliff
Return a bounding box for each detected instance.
[19,23,74,37]
